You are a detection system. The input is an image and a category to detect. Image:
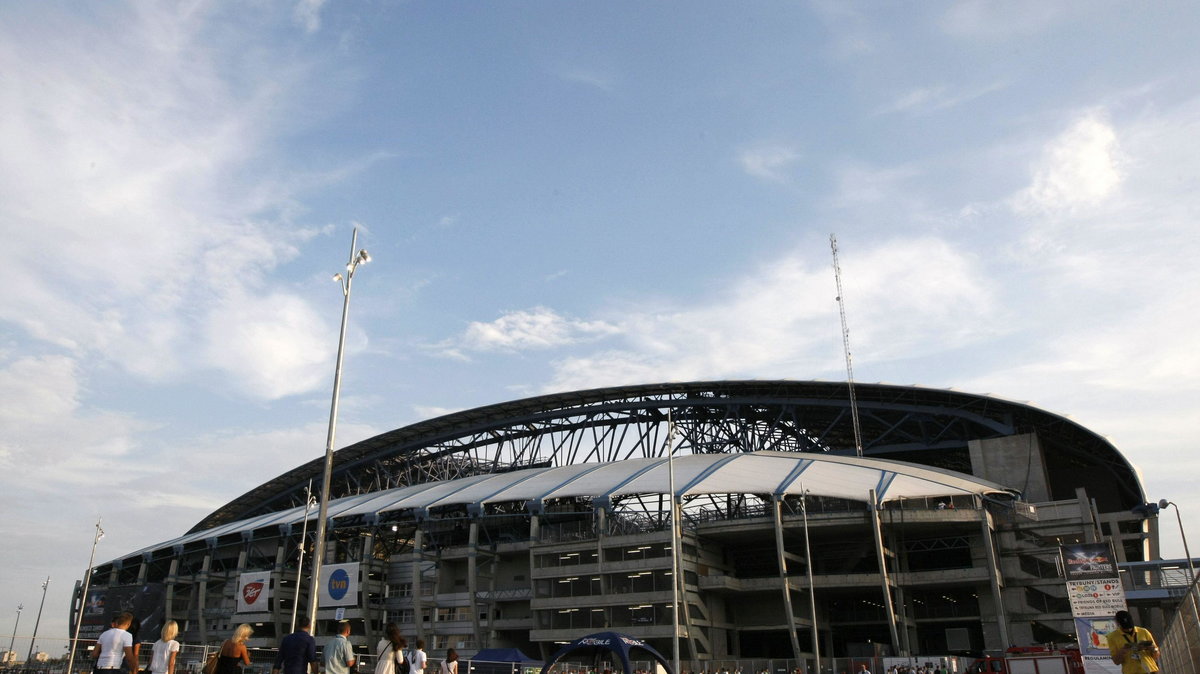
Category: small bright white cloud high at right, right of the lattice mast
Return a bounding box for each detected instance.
[1014,112,1122,212]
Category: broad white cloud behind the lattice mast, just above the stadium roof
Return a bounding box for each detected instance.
[546,237,997,391]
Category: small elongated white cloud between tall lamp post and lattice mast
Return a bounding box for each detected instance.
[457,307,619,351]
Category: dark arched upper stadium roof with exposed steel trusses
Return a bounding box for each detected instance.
[192,381,1144,534]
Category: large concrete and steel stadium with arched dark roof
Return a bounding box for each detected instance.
[72,380,1158,662]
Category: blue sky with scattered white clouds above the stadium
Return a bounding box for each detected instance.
[0,0,1200,654]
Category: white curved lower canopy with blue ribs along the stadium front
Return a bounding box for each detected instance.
[119,451,1014,556]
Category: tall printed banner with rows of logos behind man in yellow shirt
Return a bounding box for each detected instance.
[1058,543,1126,674]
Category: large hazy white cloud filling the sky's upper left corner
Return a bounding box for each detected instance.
[0,4,343,398]
